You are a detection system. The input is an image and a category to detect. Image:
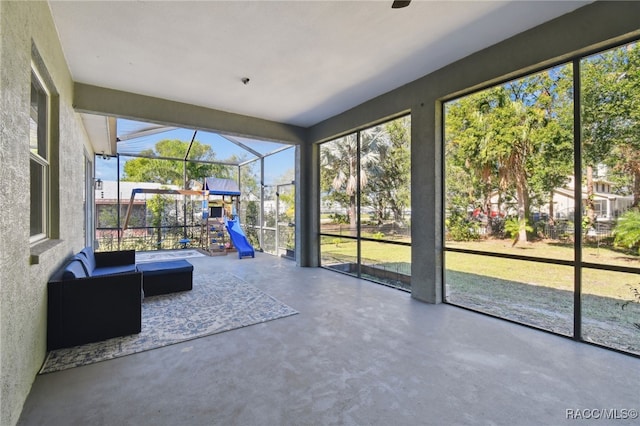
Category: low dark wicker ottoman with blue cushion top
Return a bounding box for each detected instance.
[137,260,193,296]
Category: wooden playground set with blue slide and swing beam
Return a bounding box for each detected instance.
[123,177,255,259]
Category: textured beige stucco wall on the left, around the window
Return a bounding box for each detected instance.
[0,1,88,425]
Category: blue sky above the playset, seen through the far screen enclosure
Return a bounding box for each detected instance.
[95,119,295,185]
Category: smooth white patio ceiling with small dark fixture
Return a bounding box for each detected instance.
[50,0,589,127]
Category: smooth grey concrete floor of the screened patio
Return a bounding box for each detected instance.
[19,254,640,425]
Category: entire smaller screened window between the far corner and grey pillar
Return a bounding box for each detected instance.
[320,116,411,290]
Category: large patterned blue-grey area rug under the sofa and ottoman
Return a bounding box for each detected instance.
[40,273,298,374]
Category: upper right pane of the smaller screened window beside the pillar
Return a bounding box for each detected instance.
[360,116,411,242]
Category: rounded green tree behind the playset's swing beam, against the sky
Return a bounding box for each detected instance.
[122,139,230,186]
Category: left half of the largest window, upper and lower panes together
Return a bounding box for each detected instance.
[445,65,575,335]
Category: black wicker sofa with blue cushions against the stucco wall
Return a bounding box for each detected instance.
[47,247,142,350]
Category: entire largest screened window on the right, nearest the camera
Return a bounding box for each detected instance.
[443,39,640,354]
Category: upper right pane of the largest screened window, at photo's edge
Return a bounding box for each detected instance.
[580,43,640,266]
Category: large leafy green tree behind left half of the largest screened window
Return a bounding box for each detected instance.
[445,69,571,241]
